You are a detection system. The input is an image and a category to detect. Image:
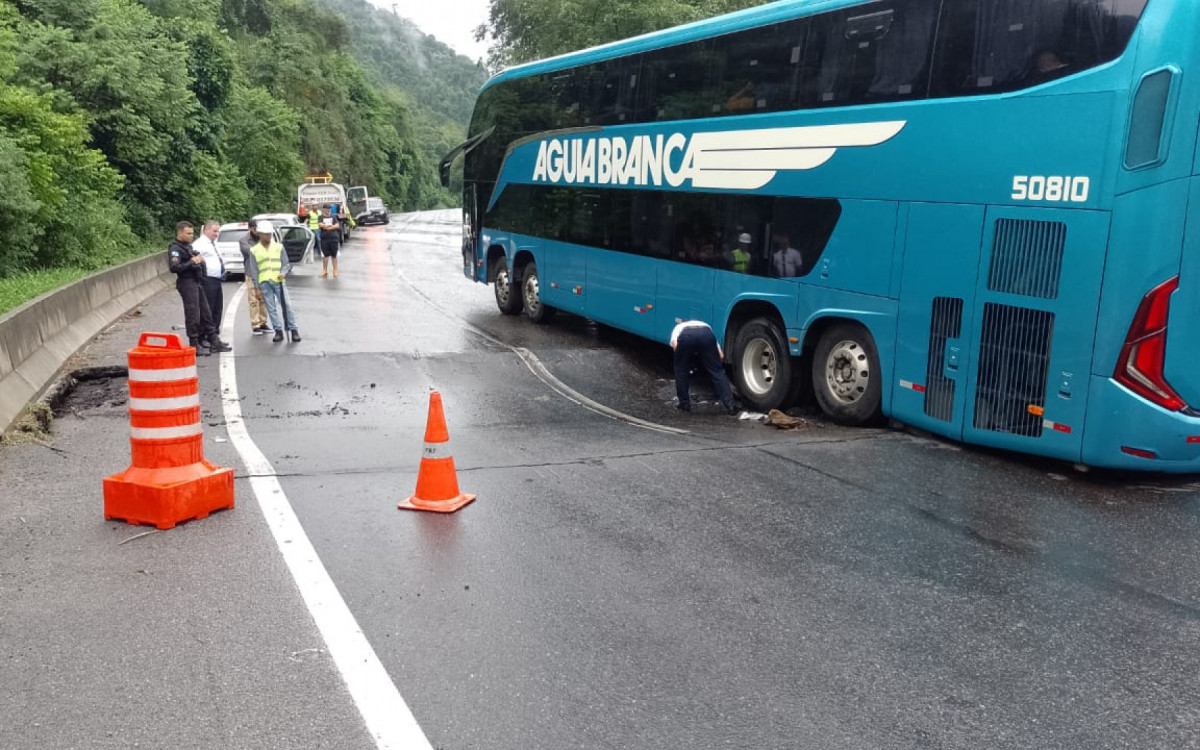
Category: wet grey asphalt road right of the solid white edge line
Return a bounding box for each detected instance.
[234,212,1200,750]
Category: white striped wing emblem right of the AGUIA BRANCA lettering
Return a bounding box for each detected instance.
[688,121,906,190]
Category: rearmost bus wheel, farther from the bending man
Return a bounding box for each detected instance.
[812,323,883,426]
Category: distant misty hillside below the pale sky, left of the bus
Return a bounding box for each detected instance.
[317,0,487,203]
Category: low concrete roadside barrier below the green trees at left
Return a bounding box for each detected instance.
[0,253,174,431]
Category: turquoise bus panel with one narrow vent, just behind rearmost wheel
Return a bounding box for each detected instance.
[892,203,984,439]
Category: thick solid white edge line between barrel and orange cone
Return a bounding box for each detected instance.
[221,284,433,750]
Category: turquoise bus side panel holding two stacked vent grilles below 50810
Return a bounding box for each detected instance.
[962,206,1109,461]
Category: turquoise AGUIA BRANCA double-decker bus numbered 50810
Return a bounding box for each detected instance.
[443,0,1200,472]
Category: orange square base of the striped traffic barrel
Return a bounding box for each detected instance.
[104,461,233,529]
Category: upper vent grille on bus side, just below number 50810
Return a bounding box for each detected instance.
[988,218,1067,300]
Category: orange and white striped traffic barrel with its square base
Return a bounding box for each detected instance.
[104,334,234,529]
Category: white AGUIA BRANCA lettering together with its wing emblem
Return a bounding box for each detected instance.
[533,120,907,190]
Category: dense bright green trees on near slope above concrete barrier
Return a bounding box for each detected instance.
[0,0,448,277]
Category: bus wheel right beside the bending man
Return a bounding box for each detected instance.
[733,318,792,412]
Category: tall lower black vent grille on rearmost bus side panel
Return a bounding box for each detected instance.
[974,302,1054,438]
